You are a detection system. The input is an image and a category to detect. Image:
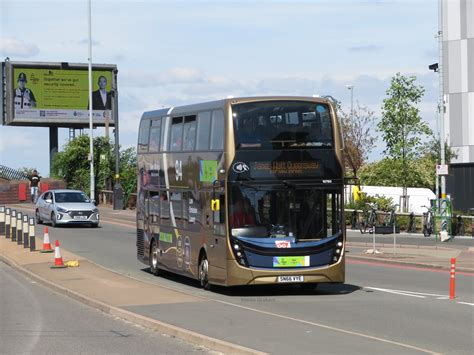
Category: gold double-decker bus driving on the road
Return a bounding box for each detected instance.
[137,96,345,289]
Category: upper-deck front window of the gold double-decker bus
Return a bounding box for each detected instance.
[232,101,333,149]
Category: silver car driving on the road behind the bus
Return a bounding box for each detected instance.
[35,190,99,227]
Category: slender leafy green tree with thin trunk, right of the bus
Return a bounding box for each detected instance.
[377,73,431,211]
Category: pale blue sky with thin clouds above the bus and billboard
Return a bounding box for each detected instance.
[0,0,438,176]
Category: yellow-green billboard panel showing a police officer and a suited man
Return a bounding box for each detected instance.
[3,61,117,127]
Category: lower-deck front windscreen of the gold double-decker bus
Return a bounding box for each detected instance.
[229,184,342,240]
